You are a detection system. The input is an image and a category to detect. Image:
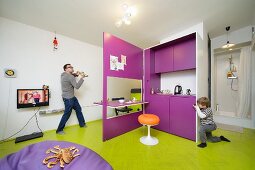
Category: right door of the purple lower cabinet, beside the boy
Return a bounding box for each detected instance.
[169,96,196,141]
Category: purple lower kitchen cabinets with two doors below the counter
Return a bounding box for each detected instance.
[145,95,196,141]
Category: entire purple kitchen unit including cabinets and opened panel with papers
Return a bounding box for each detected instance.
[103,33,197,141]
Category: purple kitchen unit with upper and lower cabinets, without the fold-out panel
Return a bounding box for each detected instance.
[144,33,196,141]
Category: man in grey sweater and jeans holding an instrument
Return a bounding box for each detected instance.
[56,64,86,134]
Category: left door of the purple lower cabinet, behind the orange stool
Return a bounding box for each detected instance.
[145,95,169,133]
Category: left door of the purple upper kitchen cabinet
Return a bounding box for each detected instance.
[155,47,174,73]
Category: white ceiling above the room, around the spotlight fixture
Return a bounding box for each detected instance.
[0,0,255,48]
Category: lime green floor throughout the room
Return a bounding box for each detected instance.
[0,121,255,170]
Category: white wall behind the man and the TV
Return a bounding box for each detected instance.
[0,18,103,139]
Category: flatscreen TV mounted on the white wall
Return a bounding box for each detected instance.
[17,89,49,109]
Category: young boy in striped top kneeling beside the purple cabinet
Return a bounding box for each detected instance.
[194,97,230,148]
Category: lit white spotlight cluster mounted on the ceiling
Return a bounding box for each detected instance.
[115,3,136,27]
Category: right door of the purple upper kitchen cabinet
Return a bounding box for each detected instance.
[173,38,196,71]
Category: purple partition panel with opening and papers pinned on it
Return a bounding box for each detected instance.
[103,33,143,141]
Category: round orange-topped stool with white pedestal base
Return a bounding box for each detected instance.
[138,114,159,145]
